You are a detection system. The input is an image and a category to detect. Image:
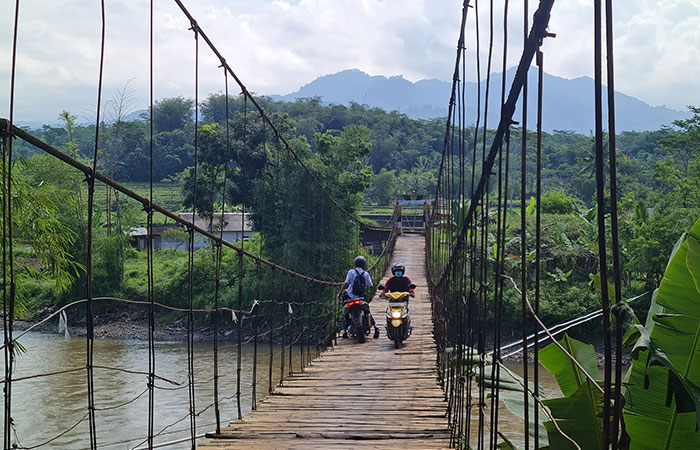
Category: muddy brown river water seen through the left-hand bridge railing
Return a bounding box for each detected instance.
[3,333,299,450]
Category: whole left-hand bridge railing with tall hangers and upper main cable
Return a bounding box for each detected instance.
[0,0,397,450]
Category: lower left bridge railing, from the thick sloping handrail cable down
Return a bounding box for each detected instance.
[0,124,344,448]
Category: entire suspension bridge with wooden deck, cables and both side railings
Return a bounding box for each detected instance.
[0,0,652,450]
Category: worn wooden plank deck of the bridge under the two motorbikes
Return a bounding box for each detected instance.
[198,235,450,450]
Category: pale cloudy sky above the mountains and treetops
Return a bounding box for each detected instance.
[0,0,700,123]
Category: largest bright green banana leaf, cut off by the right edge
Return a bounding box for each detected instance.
[624,216,700,450]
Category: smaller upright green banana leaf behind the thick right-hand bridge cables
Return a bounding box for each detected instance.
[539,334,604,450]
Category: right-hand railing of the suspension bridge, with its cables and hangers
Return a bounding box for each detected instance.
[426,0,624,450]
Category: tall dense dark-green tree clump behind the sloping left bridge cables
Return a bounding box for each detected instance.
[247,127,372,279]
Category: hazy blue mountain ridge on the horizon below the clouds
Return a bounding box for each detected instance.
[270,68,690,134]
